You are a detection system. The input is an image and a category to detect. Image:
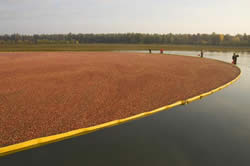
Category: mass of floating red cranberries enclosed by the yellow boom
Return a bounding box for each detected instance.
[0,52,240,147]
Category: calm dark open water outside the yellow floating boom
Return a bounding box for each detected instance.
[0,51,250,166]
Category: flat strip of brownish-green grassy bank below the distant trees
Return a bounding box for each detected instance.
[0,44,250,52]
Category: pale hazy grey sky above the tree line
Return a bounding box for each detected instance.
[0,0,250,34]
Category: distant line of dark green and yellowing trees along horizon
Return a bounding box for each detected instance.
[0,33,250,46]
